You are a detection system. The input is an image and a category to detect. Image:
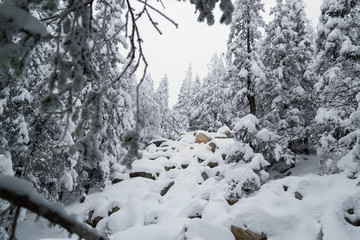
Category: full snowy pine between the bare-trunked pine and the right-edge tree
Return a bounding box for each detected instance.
[261,0,315,152]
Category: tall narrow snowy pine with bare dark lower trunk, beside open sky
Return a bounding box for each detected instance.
[227,0,265,116]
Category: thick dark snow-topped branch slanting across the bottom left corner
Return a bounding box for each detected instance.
[0,174,106,240]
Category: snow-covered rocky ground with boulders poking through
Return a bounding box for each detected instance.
[17,133,360,240]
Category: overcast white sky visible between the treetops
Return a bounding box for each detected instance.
[137,0,322,106]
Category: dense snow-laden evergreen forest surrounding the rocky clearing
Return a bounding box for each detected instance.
[0,0,360,236]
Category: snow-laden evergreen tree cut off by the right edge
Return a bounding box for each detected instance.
[315,0,360,177]
